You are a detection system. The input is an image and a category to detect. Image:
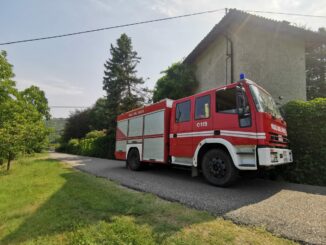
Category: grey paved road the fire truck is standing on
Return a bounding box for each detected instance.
[51,153,326,244]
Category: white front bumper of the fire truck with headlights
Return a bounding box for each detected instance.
[258,147,293,167]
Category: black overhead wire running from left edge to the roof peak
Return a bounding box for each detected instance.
[0,8,225,46]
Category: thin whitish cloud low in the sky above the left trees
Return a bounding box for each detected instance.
[15,78,84,96]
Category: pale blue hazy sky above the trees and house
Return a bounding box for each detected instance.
[0,0,326,117]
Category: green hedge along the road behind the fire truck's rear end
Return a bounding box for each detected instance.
[56,130,115,159]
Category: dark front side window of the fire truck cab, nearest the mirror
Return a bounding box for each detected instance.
[216,88,237,114]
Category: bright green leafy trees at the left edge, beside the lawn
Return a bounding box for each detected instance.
[0,49,48,170]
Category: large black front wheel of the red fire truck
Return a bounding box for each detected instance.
[201,149,239,187]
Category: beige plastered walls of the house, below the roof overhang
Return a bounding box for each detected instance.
[195,25,306,104]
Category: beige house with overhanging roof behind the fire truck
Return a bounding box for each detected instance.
[184,9,326,103]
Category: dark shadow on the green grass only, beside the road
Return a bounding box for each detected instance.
[1,159,213,244]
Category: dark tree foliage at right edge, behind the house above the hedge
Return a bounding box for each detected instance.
[306,28,326,100]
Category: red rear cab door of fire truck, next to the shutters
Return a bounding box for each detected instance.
[170,98,193,158]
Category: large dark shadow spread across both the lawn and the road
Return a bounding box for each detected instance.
[7,156,325,244]
